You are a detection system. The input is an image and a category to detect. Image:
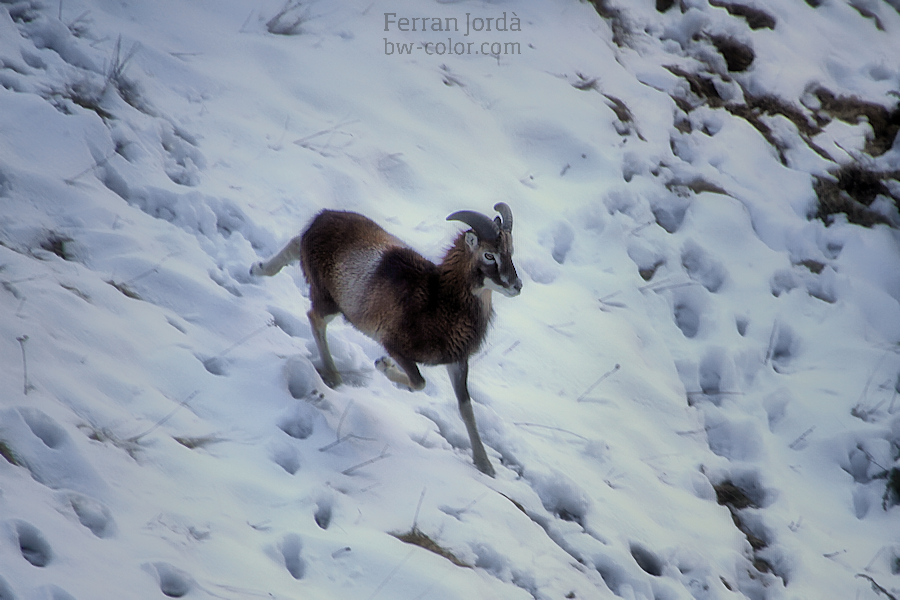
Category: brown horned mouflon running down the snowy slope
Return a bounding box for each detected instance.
[251,205,522,475]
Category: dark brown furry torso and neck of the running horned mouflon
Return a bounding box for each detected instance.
[300,211,502,365]
